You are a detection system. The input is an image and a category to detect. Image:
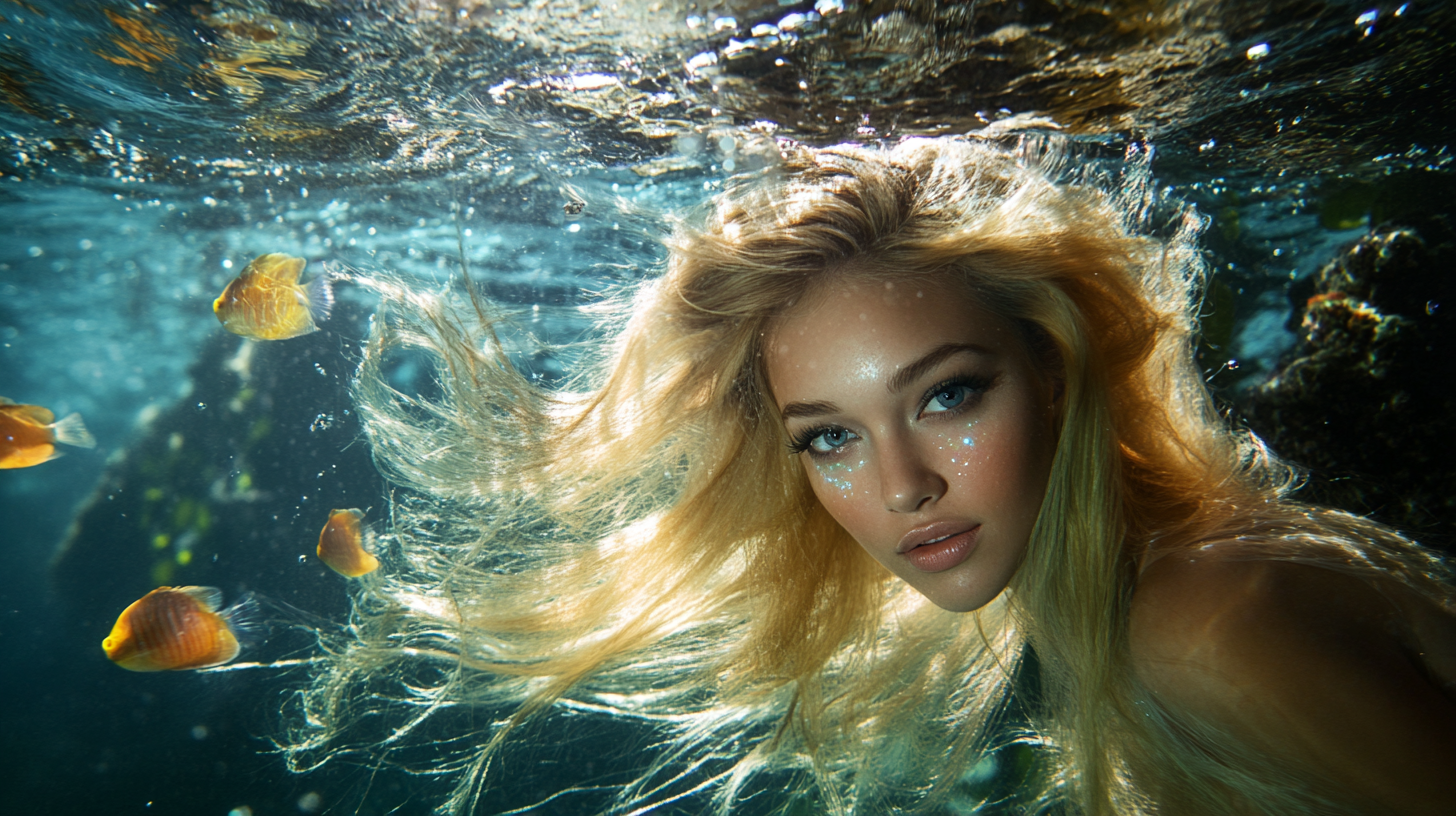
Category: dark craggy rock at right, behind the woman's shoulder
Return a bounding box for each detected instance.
[1241,216,1456,549]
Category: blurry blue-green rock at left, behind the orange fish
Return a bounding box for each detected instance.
[52,292,383,622]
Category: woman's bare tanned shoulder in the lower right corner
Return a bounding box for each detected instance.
[1130,548,1456,813]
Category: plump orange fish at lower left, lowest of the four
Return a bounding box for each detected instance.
[100,587,253,672]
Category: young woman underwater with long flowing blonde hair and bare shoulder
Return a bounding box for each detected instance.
[284,138,1456,815]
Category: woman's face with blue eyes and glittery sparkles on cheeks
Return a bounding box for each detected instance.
[766,278,1056,612]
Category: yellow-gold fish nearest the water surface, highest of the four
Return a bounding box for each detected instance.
[213,252,333,340]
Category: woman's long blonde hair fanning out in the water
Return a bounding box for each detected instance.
[281,138,1444,815]
